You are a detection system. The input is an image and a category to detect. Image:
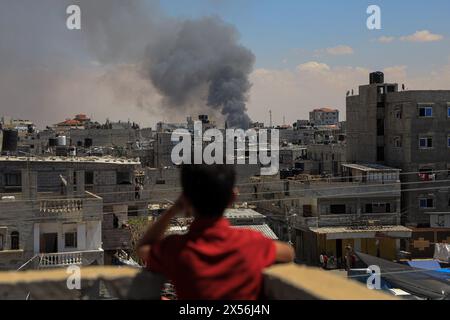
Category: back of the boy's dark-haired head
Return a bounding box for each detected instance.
[181,164,236,218]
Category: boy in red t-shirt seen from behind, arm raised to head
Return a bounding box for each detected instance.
[138,165,294,300]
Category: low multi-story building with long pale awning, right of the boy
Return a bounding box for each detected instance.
[248,164,411,264]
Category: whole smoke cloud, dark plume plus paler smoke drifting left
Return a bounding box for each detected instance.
[0,0,255,127]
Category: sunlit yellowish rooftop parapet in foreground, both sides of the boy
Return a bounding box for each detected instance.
[0,264,394,300]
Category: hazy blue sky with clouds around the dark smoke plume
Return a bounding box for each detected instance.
[0,0,450,126]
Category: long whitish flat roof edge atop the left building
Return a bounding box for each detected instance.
[0,156,141,165]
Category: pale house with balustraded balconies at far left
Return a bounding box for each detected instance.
[0,158,104,270]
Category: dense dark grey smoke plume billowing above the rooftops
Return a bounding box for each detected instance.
[147,17,255,128]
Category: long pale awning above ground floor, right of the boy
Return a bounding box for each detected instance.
[310,225,412,240]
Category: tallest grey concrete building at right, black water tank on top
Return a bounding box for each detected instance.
[347,74,450,227]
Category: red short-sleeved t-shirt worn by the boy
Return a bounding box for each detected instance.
[147,218,276,300]
